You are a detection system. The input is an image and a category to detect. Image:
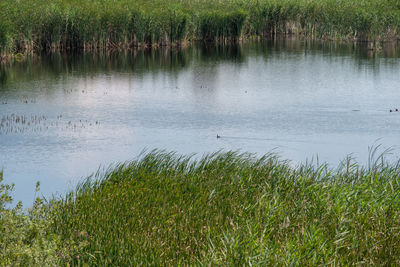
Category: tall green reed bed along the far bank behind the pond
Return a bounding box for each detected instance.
[0,0,400,57]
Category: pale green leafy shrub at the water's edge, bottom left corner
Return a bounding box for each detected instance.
[0,172,82,266]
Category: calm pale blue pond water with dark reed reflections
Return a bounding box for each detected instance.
[0,40,400,204]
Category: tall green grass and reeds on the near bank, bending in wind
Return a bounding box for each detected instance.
[0,152,400,266]
